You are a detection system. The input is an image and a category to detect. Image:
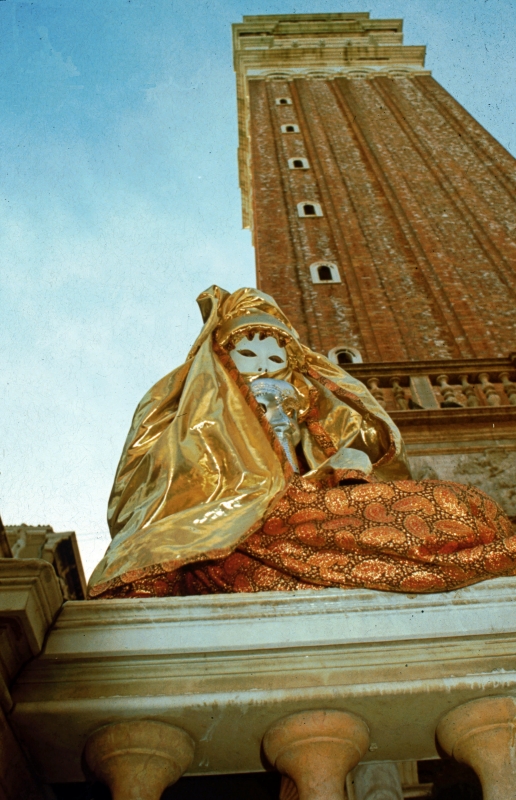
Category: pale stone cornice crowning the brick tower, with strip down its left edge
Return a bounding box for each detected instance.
[233,13,430,228]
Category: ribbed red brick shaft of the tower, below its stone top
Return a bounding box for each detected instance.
[249,76,516,361]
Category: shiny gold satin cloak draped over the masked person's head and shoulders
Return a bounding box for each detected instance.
[90,286,409,597]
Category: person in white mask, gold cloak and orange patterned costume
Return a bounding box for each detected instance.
[90,287,516,598]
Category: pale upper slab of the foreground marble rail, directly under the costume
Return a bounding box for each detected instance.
[45,578,516,658]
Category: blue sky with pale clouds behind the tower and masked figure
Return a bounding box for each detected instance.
[0,0,516,572]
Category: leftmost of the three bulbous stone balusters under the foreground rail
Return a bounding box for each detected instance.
[84,720,195,800]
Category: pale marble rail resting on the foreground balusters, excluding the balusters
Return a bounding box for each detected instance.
[11,578,516,783]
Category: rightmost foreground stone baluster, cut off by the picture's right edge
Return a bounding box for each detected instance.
[437,697,516,800]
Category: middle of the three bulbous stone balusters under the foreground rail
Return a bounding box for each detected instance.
[263,710,369,800]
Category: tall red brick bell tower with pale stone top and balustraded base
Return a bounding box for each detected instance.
[233,13,516,515]
